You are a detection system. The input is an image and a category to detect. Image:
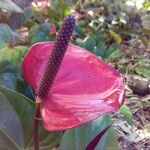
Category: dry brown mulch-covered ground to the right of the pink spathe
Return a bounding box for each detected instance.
[113,45,150,150]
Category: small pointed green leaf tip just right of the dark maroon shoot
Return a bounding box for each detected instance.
[104,127,119,150]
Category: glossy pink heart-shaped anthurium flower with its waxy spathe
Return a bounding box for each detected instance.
[22,14,124,131]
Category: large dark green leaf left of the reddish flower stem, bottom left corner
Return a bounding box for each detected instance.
[0,86,34,147]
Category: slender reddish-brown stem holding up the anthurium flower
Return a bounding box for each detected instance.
[33,103,40,150]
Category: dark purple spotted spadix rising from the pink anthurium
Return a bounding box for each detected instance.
[36,14,76,98]
